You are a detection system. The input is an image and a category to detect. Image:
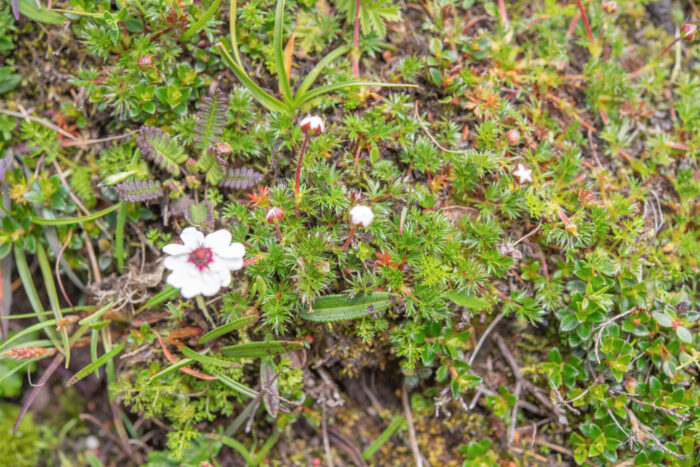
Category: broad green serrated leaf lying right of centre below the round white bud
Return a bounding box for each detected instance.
[299,292,392,322]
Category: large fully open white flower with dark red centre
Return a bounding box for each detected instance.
[163,227,245,298]
